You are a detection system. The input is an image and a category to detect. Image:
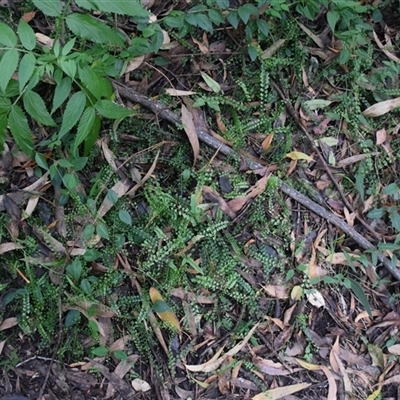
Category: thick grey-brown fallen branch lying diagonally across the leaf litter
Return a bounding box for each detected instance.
[113,81,400,281]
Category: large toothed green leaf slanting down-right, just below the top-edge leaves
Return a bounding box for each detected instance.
[66,13,124,47]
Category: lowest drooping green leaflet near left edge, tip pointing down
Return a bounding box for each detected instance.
[8,105,34,158]
